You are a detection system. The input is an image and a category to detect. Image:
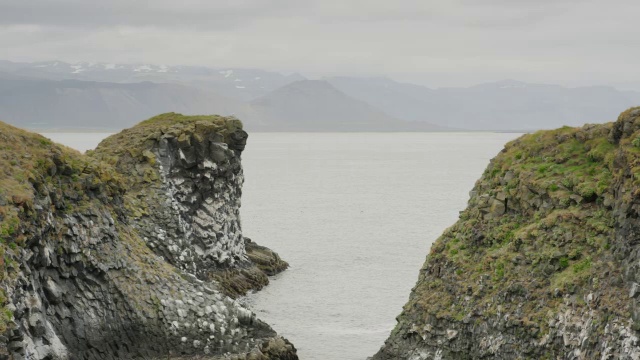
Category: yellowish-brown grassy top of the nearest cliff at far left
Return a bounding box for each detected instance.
[0,122,124,333]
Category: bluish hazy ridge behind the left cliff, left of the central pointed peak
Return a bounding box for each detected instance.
[0,74,246,130]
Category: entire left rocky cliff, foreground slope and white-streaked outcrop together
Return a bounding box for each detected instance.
[0,114,297,359]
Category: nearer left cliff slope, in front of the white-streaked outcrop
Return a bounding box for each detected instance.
[0,120,297,359]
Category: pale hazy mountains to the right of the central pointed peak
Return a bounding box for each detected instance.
[326,77,640,130]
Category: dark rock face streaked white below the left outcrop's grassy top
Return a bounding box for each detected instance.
[127,125,246,278]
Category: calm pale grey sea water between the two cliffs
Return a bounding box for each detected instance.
[38,133,519,360]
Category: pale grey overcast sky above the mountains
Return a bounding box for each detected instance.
[0,0,640,86]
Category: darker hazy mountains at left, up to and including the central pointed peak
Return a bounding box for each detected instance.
[0,73,437,131]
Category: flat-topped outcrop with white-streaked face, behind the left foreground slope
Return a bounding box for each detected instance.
[90,113,288,295]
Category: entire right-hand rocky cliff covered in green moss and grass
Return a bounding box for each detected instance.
[373,108,640,360]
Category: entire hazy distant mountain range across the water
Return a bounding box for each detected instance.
[0,61,640,131]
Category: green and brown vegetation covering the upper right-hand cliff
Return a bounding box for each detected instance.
[414,119,628,324]
